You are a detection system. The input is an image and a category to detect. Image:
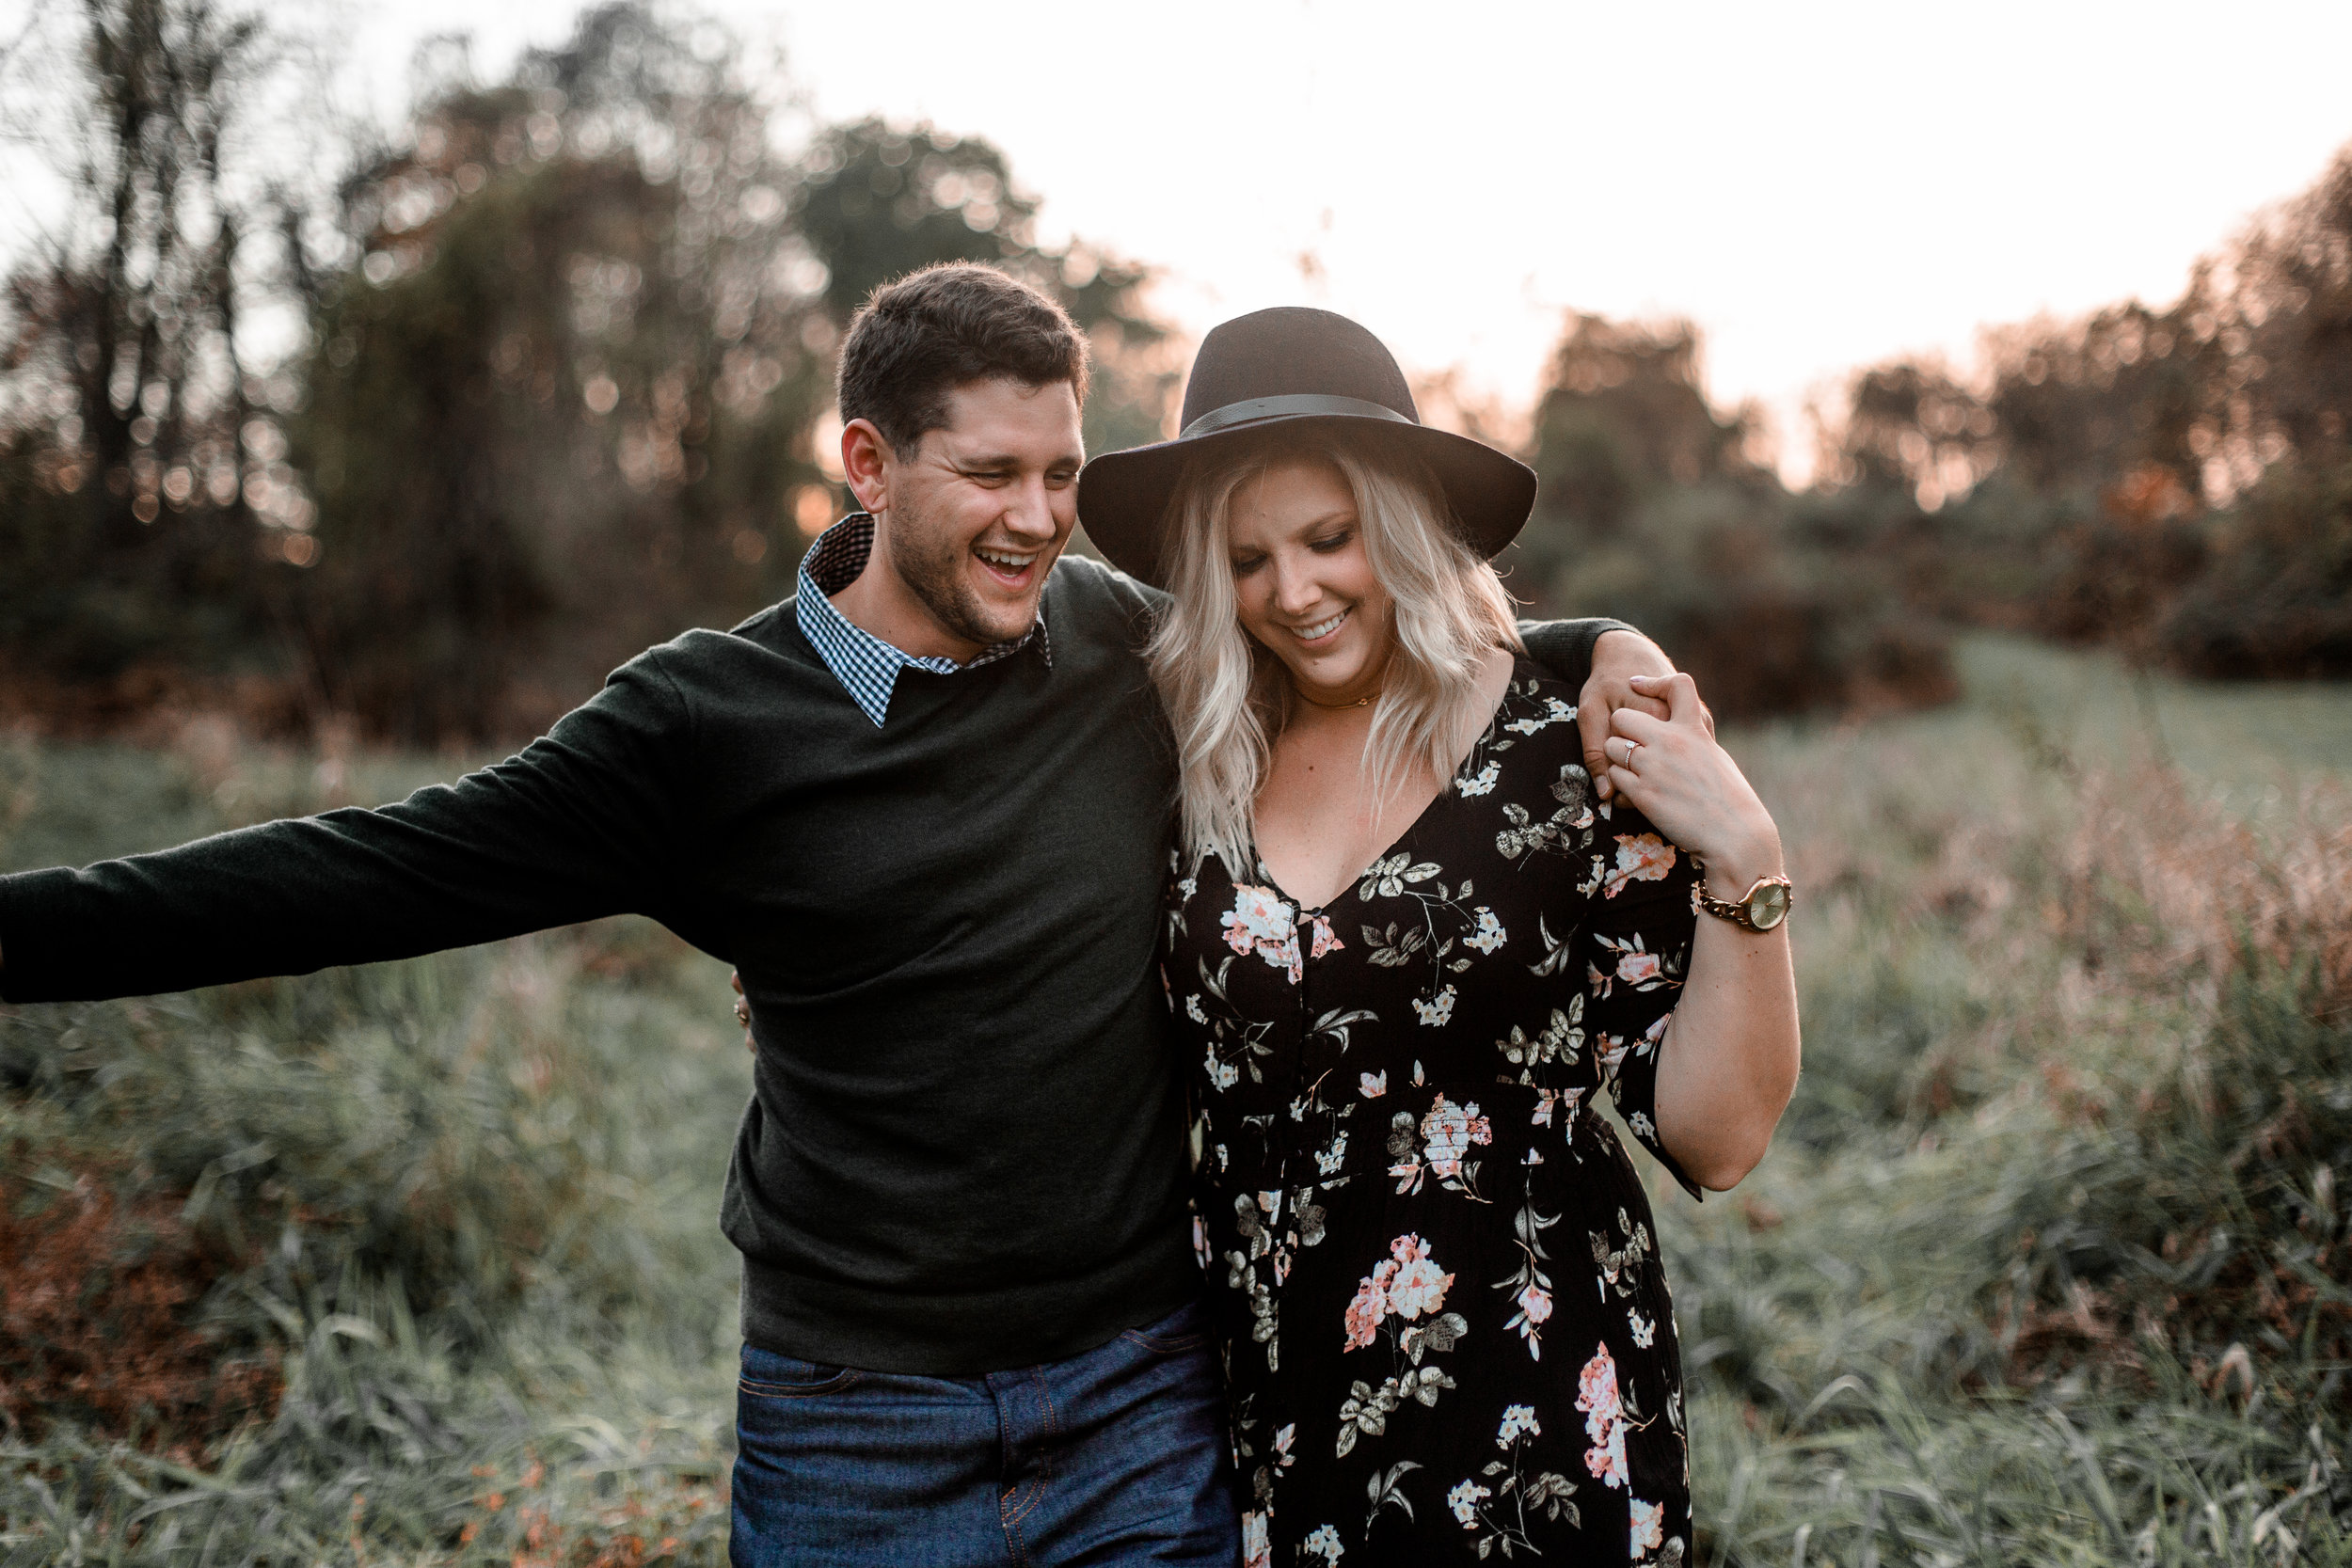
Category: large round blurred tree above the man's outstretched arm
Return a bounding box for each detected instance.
[294,5,833,740]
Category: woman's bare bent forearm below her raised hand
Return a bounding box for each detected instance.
[1659,842,1800,1192]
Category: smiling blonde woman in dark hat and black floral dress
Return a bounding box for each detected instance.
[1080,310,1797,1563]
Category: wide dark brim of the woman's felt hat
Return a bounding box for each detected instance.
[1077,414,1536,588]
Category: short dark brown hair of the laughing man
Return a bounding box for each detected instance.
[835,261,1087,456]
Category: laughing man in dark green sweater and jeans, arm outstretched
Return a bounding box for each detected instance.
[0,265,1668,1563]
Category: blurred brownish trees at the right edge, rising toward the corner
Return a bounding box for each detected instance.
[1806,148,2352,674]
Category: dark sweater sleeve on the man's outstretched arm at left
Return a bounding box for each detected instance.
[0,649,691,1002]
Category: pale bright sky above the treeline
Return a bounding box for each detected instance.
[13,0,2352,477]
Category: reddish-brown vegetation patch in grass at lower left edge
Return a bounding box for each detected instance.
[0,1171,285,1444]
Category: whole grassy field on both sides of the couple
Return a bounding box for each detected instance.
[0,640,2352,1566]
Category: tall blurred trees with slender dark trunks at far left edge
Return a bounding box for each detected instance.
[0,0,306,677]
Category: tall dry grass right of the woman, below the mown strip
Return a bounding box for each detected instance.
[1661,705,2352,1563]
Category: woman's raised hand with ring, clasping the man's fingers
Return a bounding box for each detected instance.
[1602,674,1781,898]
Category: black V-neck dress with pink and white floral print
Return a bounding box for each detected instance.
[1162,660,1698,1568]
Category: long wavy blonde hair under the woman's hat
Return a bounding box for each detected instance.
[1146,430,1522,877]
